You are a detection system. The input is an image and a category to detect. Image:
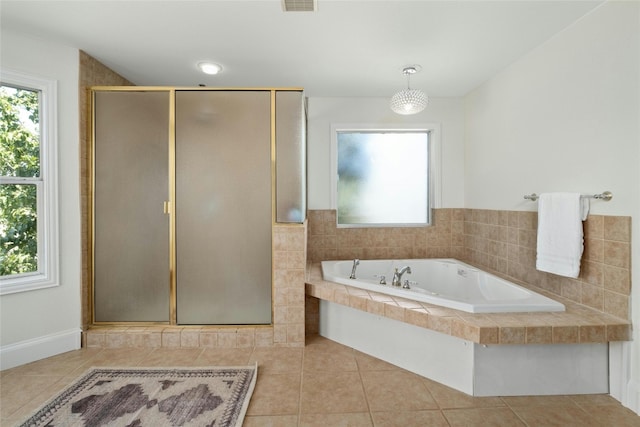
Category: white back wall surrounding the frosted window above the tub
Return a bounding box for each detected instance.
[307,97,464,209]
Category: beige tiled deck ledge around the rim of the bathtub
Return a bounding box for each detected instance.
[305,263,631,344]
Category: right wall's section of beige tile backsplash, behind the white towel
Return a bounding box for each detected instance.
[464,209,631,319]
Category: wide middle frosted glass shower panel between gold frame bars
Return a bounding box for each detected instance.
[175,91,272,324]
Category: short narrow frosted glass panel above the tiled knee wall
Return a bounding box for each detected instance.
[276,91,307,223]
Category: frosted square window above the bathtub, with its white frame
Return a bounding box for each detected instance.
[332,125,439,227]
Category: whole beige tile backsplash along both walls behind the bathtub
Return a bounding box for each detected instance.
[308,209,631,319]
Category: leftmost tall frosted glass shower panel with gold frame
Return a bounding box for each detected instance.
[94,92,169,322]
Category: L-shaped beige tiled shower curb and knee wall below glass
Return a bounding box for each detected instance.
[83,223,307,348]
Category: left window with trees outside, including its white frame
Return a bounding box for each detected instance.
[0,69,58,294]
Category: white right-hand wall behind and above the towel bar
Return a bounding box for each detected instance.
[464,2,640,411]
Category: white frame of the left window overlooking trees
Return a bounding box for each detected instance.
[0,68,60,295]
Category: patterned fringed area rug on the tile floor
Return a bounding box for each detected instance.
[22,364,258,427]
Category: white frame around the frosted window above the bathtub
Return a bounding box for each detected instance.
[331,123,442,228]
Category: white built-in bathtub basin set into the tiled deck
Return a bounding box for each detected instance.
[322,259,565,313]
